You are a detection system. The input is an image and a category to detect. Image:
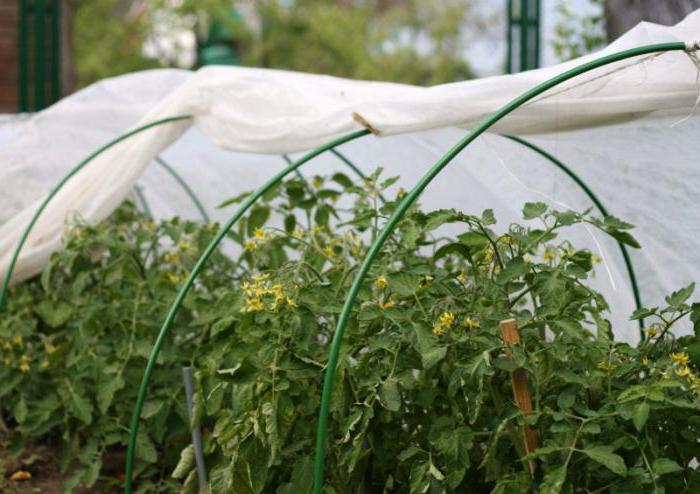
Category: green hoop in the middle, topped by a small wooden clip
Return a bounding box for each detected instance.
[124,129,370,494]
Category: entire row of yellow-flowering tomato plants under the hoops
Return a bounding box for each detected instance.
[0,173,700,494]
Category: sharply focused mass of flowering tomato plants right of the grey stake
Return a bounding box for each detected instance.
[182,172,700,494]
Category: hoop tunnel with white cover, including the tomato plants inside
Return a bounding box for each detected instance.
[0,4,700,494]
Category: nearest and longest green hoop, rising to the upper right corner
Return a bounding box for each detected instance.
[313,42,686,494]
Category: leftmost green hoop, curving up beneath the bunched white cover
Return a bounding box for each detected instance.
[0,115,192,310]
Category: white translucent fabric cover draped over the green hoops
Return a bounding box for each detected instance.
[0,11,700,339]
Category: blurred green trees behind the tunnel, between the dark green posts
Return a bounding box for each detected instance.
[74,0,473,87]
